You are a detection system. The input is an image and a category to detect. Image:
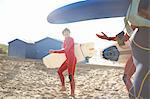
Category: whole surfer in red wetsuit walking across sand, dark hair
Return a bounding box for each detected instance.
[49,28,77,97]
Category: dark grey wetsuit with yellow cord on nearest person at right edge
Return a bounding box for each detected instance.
[130,27,150,99]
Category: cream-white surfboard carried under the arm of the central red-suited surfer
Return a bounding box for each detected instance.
[43,43,95,68]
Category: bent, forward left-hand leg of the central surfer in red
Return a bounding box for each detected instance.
[57,61,67,91]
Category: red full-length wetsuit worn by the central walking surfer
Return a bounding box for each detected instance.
[54,37,77,86]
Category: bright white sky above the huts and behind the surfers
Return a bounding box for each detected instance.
[0,0,124,48]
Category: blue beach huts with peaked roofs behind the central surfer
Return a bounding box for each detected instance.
[8,37,62,59]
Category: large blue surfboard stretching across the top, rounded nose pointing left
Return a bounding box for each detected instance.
[47,0,129,24]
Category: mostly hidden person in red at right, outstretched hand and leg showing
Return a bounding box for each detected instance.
[96,31,136,92]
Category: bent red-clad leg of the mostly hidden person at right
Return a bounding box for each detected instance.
[123,56,136,91]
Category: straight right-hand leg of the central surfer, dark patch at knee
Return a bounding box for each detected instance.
[68,59,77,96]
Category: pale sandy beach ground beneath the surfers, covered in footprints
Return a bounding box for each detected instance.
[0,56,128,99]
